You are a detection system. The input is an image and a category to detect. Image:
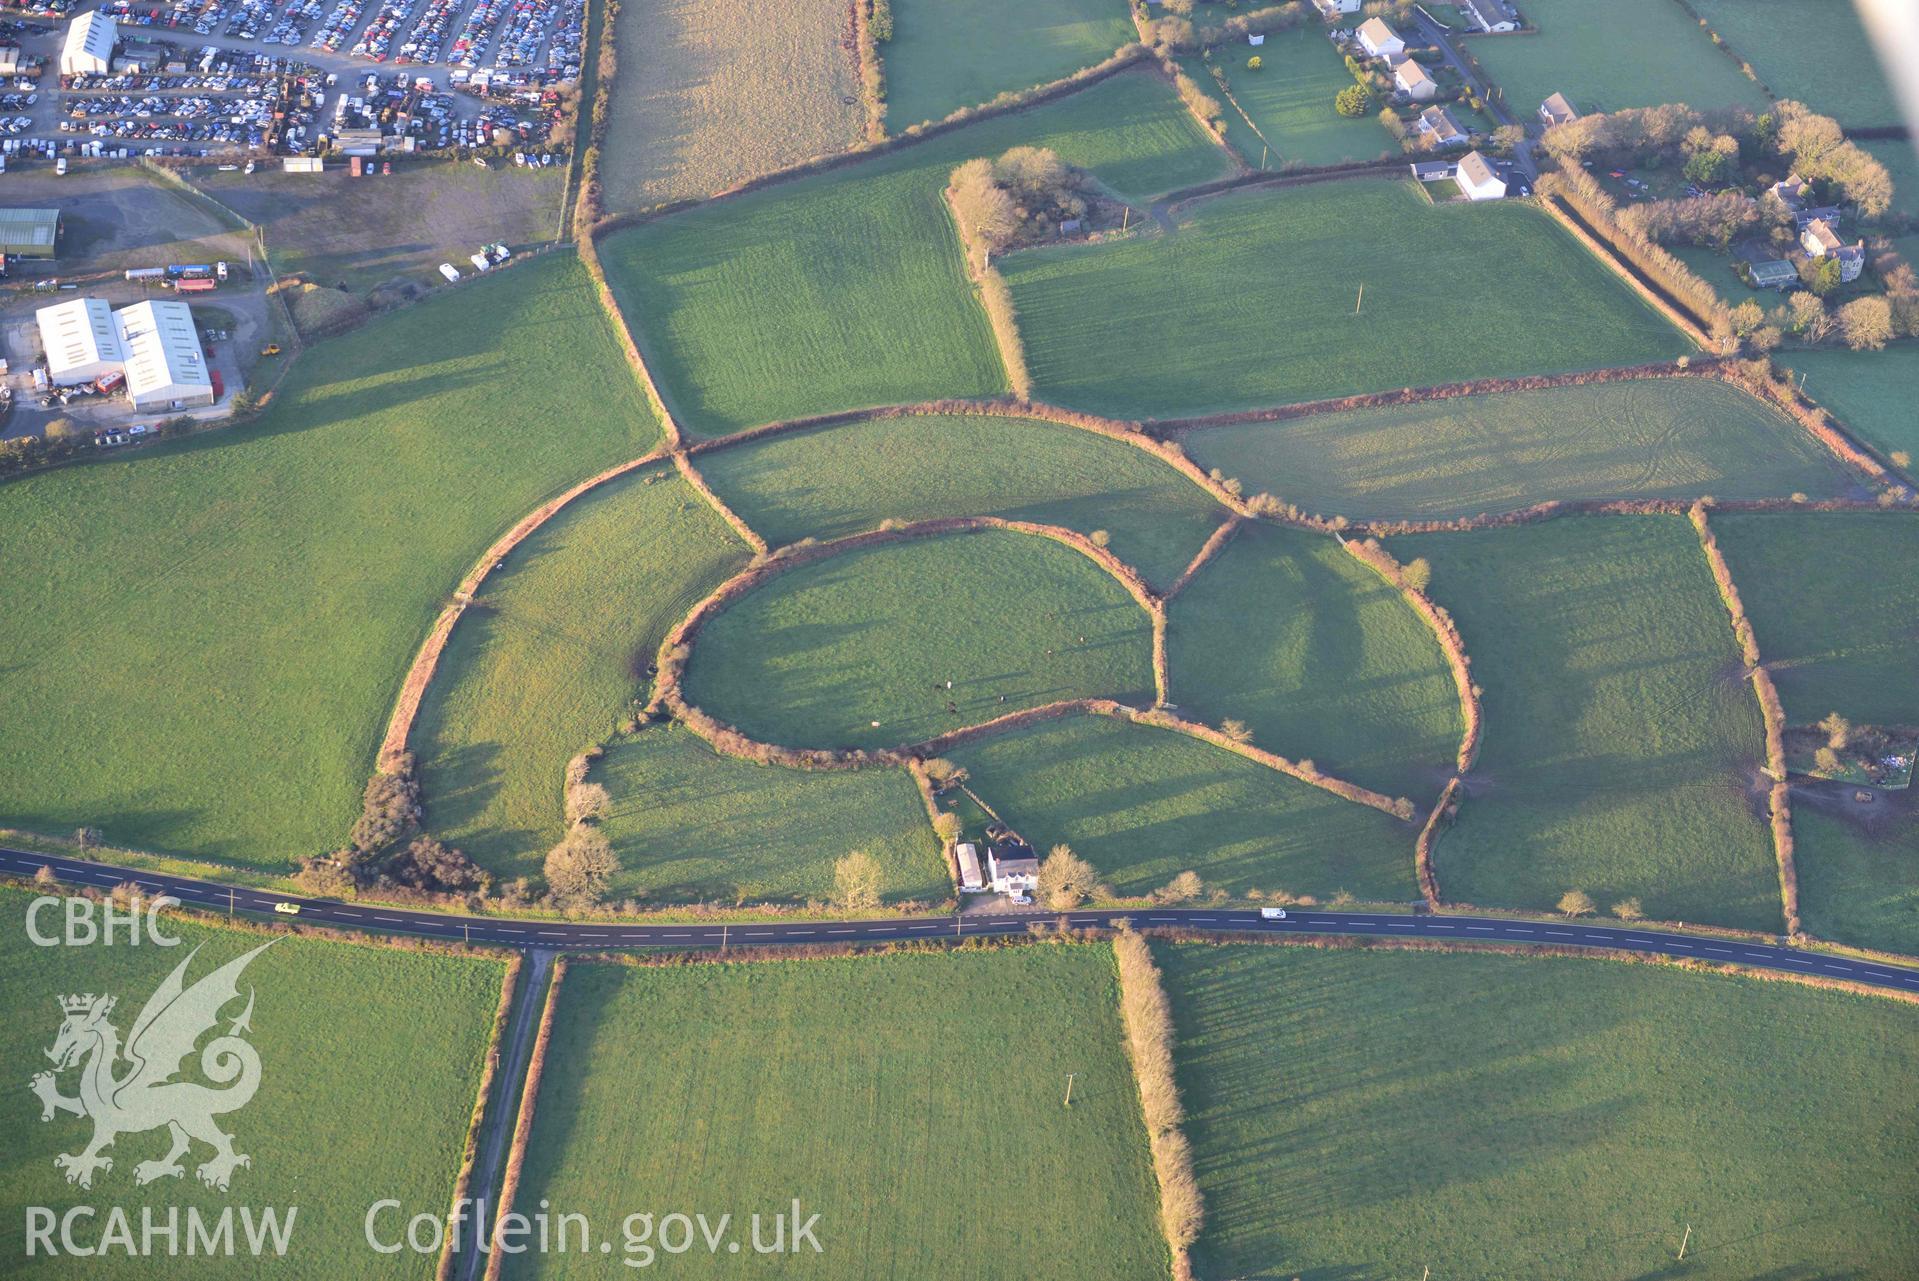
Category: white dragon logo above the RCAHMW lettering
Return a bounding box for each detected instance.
[27,942,272,1193]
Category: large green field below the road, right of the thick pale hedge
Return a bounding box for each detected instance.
[1155,945,1919,1281]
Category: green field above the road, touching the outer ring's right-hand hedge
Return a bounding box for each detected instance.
[1389,516,1781,930]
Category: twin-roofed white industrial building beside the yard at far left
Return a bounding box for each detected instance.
[35,297,213,410]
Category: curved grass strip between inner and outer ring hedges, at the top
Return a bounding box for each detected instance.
[699,414,1222,587]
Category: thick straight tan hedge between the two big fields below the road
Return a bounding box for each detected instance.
[1113,930,1205,1281]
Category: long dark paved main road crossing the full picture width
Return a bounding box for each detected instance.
[11,850,1919,991]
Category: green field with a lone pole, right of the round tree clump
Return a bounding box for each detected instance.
[1002,178,1683,418]
